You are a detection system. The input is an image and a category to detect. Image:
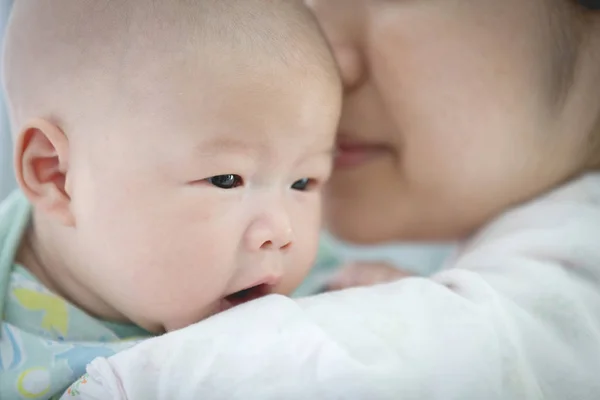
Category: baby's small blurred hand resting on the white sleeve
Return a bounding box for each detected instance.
[324,262,412,291]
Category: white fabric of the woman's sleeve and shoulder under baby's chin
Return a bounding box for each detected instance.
[63,175,600,400]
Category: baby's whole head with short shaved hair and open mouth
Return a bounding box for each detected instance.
[4,0,341,332]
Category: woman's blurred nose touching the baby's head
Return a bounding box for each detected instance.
[306,0,366,91]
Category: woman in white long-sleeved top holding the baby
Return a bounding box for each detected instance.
[72,0,600,400]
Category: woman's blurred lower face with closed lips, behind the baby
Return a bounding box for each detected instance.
[307,0,600,243]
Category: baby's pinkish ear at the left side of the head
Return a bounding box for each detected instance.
[14,119,75,226]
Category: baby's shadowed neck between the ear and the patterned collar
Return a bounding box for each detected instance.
[15,212,128,322]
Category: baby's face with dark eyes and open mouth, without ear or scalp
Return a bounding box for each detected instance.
[68,65,340,331]
